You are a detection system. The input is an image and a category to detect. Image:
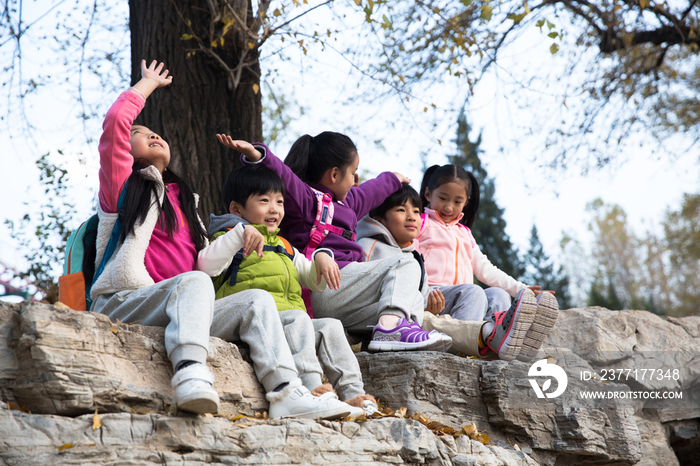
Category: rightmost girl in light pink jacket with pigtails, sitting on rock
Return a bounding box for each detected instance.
[418,165,559,361]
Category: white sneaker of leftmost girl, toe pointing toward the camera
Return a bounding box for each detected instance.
[170,364,219,414]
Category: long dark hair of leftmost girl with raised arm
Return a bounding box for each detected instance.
[120,160,207,251]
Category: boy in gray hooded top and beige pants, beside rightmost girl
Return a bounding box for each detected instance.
[357,183,556,359]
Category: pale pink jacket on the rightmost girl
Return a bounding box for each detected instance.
[418,209,527,297]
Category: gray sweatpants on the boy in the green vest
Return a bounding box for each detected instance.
[279,310,365,401]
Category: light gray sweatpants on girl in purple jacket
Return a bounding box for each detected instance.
[311,254,423,332]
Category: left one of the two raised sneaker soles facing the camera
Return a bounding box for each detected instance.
[482,289,539,361]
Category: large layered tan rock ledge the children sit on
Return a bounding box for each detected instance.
[0,303,700,466]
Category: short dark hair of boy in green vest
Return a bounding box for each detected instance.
[221,165,285,208]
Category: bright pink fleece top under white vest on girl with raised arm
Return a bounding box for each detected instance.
[98,90,197,282]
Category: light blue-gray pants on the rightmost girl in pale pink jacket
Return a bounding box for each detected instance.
[431,285,511,321]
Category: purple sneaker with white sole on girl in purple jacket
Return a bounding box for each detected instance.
[369,318,452,351]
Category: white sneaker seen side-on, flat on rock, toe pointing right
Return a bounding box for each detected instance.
[267,379,352,419]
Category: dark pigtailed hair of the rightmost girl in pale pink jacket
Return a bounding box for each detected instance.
[420,165,481,228]
